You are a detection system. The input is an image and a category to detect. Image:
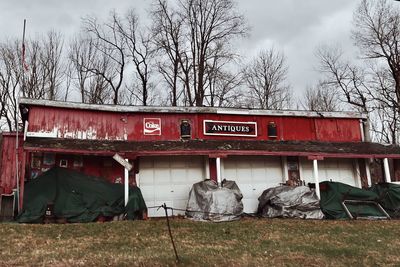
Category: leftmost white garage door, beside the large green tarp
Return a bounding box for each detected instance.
[137,156,205,217]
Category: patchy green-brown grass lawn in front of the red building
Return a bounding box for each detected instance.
[0,219,400,266]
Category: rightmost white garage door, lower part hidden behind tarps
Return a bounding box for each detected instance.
[300,158,361,187]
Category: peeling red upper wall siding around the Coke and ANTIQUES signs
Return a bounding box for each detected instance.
[28,106,361,142]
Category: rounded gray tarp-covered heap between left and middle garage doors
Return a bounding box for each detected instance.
[186,180,243,222]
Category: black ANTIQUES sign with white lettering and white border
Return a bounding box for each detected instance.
[203,120,257,137]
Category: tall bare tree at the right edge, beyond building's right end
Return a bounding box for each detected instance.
[353,0,400,143]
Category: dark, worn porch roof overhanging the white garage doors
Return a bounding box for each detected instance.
[24,138,400,158]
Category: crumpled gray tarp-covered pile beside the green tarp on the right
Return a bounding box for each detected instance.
[258,186,324,219]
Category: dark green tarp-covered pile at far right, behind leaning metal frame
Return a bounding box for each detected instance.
[320,182,400,219]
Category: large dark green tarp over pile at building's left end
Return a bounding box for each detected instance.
[17,167,146,223]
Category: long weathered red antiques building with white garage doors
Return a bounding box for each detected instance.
[2,99,400,216]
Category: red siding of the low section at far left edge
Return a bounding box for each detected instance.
[0,133,23,194]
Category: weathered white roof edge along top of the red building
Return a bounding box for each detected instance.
[19,98,368,119]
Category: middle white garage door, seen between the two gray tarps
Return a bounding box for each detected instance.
[222,156,284,213]
